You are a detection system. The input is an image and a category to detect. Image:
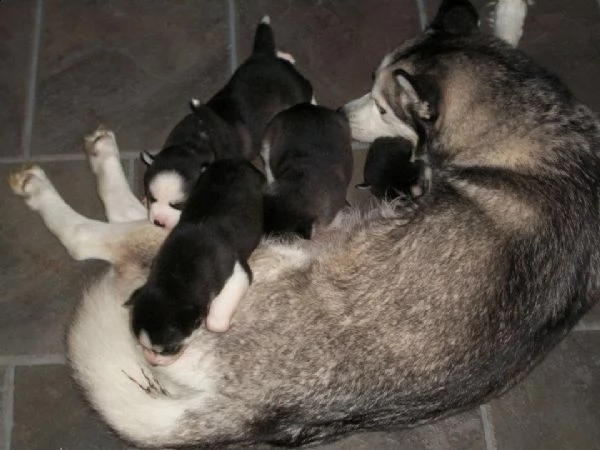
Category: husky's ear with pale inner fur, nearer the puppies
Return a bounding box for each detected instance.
[394,69,439,121]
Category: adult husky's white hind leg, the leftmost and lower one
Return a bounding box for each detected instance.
[9,165,153,264]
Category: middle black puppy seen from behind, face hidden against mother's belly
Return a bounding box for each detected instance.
[261,103,353,239]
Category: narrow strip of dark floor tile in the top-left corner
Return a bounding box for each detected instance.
[0,0,36,156]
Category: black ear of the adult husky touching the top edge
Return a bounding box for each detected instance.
[430,0,479,36]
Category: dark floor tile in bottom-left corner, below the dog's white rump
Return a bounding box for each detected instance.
[12,366,128,450]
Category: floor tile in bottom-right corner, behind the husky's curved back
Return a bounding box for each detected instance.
[491,332,600,450]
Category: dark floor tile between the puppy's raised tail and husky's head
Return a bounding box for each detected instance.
[237,0,419,108]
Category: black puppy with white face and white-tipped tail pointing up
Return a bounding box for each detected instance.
[139,17,313,228]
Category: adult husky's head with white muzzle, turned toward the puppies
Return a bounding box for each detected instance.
[342,0,478,145]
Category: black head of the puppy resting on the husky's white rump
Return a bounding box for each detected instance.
[125,285,201,366]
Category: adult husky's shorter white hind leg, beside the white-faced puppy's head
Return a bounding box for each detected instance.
[84,125,147,222]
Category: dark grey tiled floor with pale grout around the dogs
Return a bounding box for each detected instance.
[0,0,600,450]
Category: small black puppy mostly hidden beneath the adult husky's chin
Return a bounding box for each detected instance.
[356,137,431,200]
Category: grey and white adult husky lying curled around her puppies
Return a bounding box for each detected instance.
[11,1,600,447]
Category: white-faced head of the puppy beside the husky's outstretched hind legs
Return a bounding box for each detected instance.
[142,147,210,229]
